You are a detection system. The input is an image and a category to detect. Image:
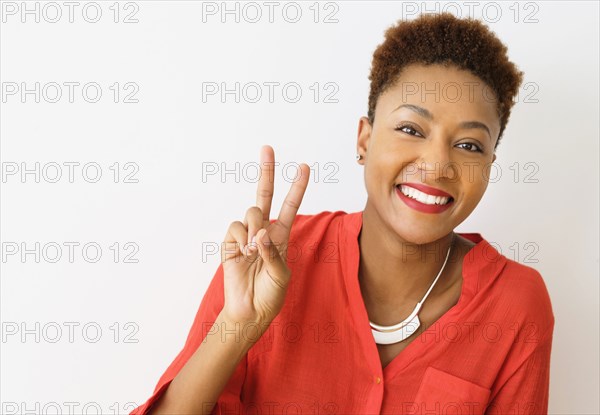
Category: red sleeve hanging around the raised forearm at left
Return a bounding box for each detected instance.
[130,264,247,415]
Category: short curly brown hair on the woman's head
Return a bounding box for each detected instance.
[368,12,523,151]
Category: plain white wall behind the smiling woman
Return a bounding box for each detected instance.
[0,1,600,414]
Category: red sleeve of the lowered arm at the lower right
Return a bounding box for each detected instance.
[485,329,552,415]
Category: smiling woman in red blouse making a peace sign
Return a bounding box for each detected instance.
[133,14,554,414]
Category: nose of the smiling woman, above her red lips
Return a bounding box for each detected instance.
[417,136,457,182]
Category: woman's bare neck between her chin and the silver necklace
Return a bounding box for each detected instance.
[359,205,458,316]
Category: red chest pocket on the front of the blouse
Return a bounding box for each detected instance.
[411,366,490,415]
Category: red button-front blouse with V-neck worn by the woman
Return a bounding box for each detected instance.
[132,211,554,415]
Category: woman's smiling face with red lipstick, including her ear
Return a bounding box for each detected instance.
[357,64,500,244]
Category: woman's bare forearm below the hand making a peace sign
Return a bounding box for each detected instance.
[149,313,260,415]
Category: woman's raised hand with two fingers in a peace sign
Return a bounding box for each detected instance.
[221,145,310,334]
